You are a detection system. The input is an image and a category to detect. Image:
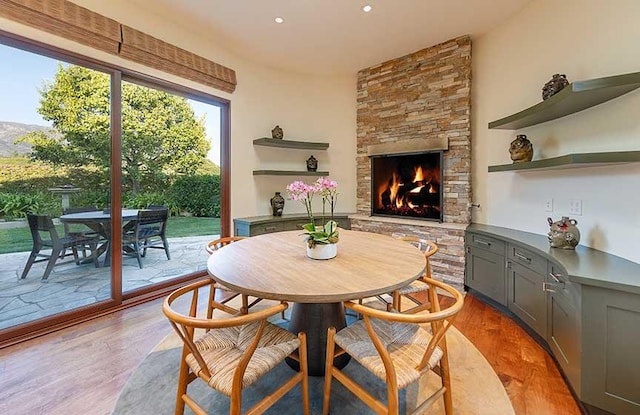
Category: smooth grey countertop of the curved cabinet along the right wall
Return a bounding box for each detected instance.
[467,223,640,294]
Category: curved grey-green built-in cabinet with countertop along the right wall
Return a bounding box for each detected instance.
[465,224,640,415]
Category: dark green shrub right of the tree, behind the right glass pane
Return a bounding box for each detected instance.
[171,175,220,217]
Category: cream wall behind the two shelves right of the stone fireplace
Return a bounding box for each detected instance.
[472,0,640,262]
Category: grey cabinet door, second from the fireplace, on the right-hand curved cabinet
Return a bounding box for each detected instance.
[507,261,547,338]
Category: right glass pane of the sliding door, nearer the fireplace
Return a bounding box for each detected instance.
[121,79,221,294]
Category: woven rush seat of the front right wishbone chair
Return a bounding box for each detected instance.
[335,320,443,389]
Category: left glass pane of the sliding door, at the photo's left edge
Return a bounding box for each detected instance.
[0,40,113,330]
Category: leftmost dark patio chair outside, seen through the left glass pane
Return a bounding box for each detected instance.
[20,213,98,281]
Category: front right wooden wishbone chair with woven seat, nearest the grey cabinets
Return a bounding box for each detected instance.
[323,279,464,415]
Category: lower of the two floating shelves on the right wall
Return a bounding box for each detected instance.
[489,151,640,173]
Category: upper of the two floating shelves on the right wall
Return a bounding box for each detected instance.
[489,72,640,130]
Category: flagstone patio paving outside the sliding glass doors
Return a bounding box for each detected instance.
[0,235,219,329]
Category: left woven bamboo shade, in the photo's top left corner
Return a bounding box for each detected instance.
[0,0,121,55]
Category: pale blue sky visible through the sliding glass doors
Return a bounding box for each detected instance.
[0,44,220,165]
